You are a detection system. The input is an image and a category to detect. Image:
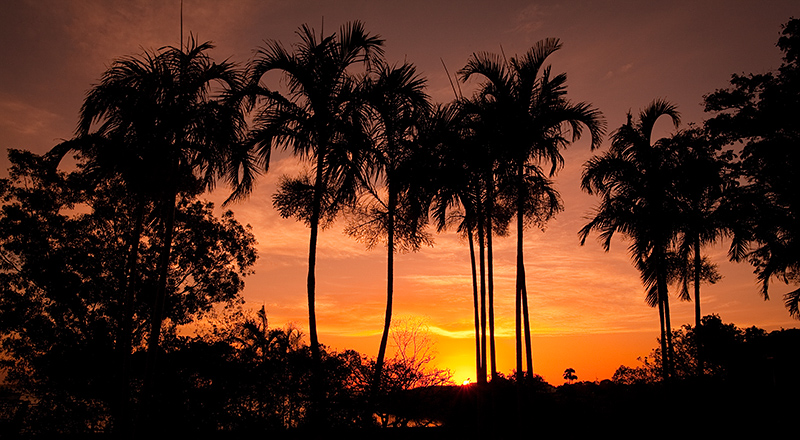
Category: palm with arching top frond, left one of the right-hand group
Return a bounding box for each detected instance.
[579,99,682,379]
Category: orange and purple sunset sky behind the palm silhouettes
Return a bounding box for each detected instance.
[0,0,800,384]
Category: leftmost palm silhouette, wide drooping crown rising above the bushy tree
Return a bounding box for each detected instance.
[69,37,250,430]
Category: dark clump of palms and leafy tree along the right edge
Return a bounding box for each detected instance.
[580,19,800,379]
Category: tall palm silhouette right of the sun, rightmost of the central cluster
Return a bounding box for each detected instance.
[460,38,605,383]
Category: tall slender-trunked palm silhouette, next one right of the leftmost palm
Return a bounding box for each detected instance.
[250,21,383,422]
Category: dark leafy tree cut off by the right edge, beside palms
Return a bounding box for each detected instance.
[705,19,800,319]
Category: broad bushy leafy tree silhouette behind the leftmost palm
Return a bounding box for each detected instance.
[0,151,256,435]
